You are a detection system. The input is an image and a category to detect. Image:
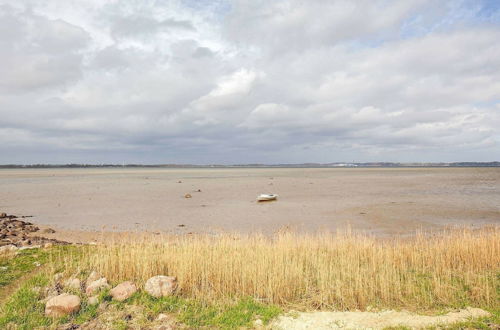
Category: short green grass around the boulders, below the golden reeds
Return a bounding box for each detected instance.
[0,275,281,329]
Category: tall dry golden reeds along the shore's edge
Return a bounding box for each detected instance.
[57,227,500,310]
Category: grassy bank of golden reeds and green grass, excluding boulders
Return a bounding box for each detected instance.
[0,228,500,329]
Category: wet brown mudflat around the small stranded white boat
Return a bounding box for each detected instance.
[0,168,500,240]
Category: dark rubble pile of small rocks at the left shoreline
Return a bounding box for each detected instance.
[0,213,69,247]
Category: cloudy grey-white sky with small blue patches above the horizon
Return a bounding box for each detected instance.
[0,0,500,164]
